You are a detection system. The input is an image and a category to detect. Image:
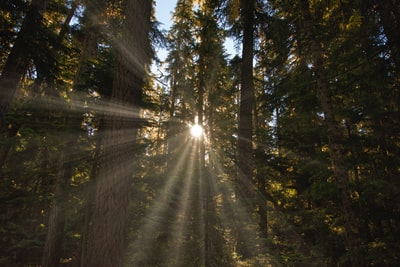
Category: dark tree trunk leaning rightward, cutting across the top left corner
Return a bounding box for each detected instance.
[0,0,48,129]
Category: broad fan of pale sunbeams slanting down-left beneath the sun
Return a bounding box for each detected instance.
[126,137,201,265]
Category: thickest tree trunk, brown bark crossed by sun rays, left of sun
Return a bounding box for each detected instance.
[81,0,152,267]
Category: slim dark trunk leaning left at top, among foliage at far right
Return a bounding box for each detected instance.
[302,4,365,267]
